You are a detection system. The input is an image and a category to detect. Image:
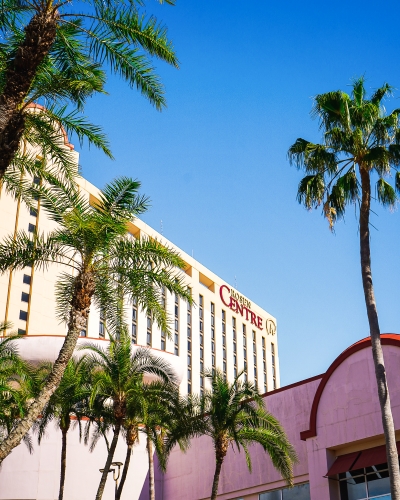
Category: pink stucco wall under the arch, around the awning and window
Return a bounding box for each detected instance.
[307,345,400,500]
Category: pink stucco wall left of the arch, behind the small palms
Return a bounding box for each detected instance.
[160,379,319,500]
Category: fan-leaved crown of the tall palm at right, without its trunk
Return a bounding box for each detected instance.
[288,78,400,228]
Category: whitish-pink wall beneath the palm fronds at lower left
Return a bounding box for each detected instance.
[0,424,148,500]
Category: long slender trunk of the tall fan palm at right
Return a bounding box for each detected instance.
[360,165,400,500]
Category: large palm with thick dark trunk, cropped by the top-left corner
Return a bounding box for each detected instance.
[0,0,178,179]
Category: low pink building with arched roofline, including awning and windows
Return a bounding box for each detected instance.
[148,334,400,500]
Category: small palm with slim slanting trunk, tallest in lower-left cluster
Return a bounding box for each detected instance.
[82,330,175,500]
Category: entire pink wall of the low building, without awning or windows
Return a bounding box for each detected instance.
[154,335,400,500]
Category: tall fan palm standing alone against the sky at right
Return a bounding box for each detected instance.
[288,78,400,500]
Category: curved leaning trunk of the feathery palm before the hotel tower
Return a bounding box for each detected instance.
[0,273,94,464]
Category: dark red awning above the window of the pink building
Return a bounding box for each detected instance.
[326,442,400,476]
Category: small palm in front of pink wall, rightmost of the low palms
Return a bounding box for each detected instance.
[196,369,297,500]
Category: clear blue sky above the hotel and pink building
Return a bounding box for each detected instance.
[77,0,400,385]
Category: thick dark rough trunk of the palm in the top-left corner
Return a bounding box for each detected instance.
[0,10,58,179]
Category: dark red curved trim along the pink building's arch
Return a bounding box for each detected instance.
[300,333,400,441]
